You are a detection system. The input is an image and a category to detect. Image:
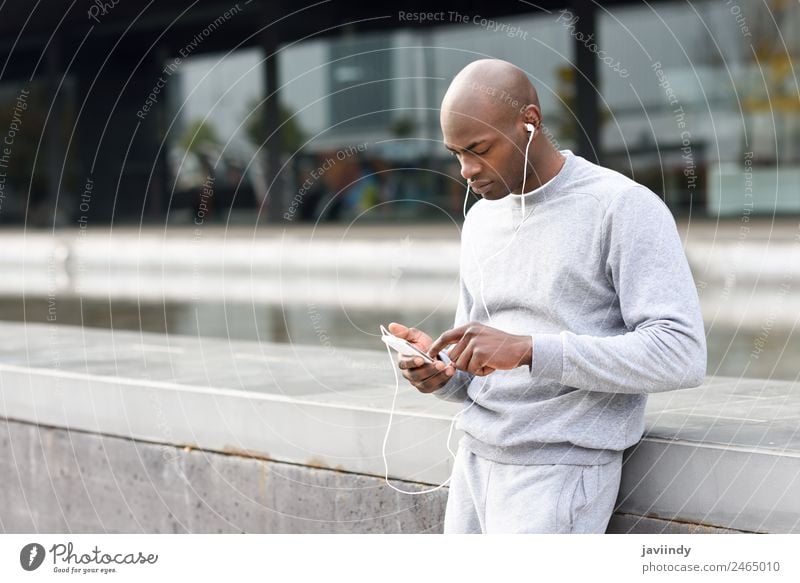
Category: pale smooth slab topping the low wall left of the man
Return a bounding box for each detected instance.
[0,325,458,483]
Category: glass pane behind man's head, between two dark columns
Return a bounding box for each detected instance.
[268,14,574,221]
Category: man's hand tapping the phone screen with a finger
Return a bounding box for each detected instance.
[428,322,533,376]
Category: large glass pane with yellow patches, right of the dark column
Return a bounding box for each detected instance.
[598,1,800,217]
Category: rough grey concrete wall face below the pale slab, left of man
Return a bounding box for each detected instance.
[0,422,447,533]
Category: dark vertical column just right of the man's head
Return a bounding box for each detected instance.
[572,0,601,162]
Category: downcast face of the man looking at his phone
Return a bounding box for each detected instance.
[442,114,524,200]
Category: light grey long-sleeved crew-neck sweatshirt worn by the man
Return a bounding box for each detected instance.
[433,150,706,464]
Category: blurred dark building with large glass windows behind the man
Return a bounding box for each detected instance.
[0,0,800,224]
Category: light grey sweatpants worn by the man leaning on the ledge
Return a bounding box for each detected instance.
[444,447,622,534]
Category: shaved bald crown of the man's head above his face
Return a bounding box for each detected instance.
[441,59,539,134]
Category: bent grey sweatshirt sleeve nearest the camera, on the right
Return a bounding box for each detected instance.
[531,186,706,394]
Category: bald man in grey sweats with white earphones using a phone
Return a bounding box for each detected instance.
[389,60,706,533]
